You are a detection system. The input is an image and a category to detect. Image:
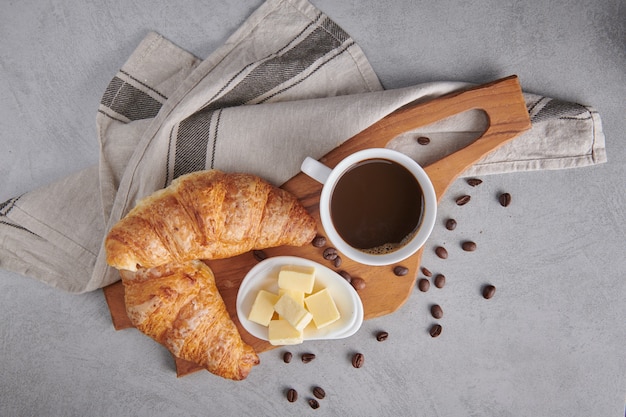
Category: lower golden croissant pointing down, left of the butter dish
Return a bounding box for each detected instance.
[121,261,259,380]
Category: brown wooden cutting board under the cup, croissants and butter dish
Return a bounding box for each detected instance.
[104,76,530,376]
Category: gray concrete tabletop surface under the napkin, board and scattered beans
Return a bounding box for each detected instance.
[0,0,626,417]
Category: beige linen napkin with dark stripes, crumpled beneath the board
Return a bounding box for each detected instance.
[0,0,606,293]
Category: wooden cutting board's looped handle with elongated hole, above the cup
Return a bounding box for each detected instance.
[310,75,530,199]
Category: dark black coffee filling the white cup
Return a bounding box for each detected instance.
[330,159,424,254]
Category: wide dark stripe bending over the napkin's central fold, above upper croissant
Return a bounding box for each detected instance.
[168,17,349,179]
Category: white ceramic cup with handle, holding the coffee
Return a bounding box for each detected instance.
[301,148,437,266]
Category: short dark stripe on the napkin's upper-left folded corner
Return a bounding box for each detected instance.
[100,77,162,121]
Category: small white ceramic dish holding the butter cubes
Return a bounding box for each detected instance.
[237,256,363,340]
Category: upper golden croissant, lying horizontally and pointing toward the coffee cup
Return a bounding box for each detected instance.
[105,170,316,271]
